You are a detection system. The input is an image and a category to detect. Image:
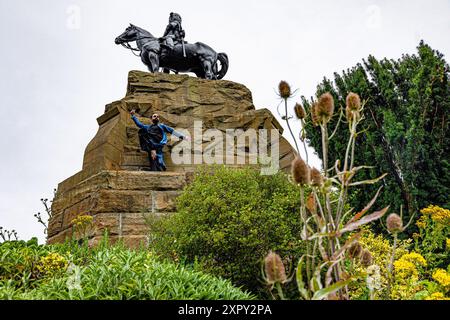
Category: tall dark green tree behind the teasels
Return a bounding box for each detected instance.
[303,42,450,231]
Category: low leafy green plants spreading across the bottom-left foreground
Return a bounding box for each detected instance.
[0,239,253,300]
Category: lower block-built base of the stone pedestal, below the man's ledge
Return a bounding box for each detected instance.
[48,170,187,243]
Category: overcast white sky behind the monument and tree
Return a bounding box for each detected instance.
[0,0,450,240]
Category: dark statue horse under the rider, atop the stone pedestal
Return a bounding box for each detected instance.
[115,24,228,80]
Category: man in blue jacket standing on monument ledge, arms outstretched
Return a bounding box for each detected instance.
[130,109,190,171]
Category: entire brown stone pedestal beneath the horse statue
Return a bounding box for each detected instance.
[48,71,294,247]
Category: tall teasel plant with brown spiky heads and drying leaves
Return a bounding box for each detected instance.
[284,88,389,300]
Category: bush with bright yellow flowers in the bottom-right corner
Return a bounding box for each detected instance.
[347,206,450,300]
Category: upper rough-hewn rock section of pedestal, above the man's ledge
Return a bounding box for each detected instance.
[79,71,292,172]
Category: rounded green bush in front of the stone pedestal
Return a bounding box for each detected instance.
[150,166,303,296]
